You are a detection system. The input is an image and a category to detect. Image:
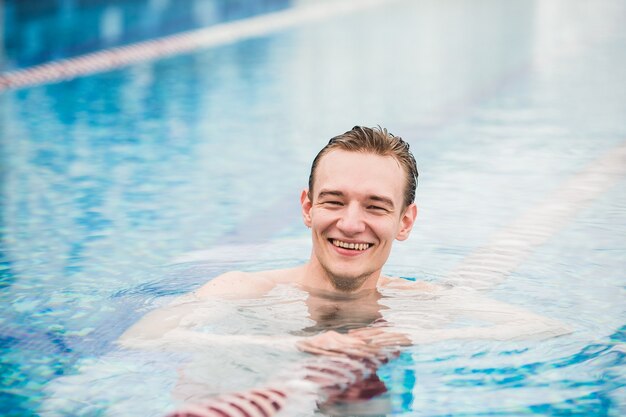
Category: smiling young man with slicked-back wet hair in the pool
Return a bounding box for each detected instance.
[119,126,568,414]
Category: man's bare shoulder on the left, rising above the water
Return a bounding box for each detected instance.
[195,269,302,299]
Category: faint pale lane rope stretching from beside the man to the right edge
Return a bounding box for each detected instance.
[448,142,626,290]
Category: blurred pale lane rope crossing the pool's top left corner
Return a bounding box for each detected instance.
[0,0,395,92]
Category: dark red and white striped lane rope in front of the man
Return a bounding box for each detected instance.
[167,351,398,417]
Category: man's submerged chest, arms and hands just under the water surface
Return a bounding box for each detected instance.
[119,267,569,354]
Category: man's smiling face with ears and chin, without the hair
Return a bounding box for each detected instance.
[301,150,417,291]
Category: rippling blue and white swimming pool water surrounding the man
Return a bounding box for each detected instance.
[0,0,626,416]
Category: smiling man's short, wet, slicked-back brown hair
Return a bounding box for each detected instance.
[309,126,418,207]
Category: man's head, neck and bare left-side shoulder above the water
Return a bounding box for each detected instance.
[197,126,418,298]
